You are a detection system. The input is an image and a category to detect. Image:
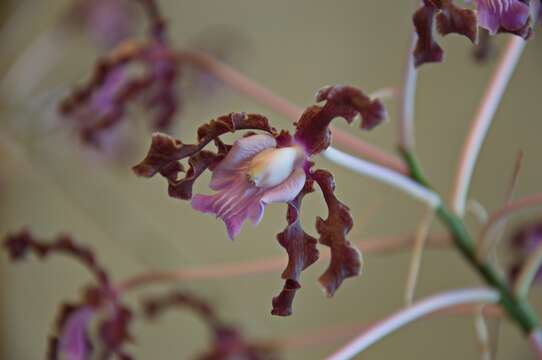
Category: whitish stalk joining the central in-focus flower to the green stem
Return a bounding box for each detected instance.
[323,148,441,208]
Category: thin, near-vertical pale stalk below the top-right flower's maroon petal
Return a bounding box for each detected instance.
[398,31,418,150]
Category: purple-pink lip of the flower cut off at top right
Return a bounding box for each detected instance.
[476,0,530,35]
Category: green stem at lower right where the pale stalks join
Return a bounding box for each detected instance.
[401,150,539,334]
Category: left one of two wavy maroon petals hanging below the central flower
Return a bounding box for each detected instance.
[271,180,319,316]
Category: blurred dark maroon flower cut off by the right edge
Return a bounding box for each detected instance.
[510,222,542,284]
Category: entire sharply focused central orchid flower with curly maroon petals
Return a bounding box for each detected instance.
[134,86,386,316]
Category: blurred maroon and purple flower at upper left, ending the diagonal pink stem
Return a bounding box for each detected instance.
[60,41,179,147]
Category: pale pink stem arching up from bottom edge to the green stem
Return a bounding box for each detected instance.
[327,288,499,360]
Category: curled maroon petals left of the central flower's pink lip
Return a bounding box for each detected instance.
[133,113,276,199]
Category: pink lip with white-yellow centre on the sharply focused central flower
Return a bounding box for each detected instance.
[192,134,306,239]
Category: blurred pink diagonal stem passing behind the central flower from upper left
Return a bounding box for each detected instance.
[175,51,407,174]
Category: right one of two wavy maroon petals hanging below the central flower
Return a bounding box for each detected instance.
[311,170,362,296]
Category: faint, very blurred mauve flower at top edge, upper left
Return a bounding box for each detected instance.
[63,0,137,49]
